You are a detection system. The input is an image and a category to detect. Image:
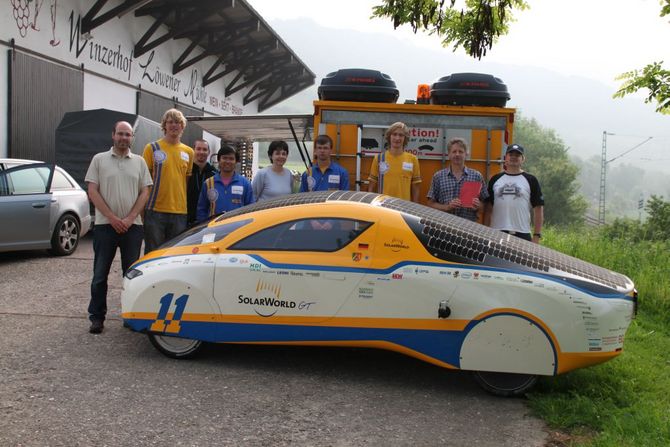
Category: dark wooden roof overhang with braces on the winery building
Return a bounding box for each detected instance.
[81,0,316,112]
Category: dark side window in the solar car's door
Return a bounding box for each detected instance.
[229,218,372,252]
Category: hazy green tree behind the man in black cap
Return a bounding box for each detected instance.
[514,115,587,226]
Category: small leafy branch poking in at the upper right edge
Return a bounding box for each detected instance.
[614,60,670,114]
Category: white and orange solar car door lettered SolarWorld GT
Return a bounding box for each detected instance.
[214,218,374,324]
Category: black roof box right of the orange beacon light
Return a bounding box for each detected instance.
[430,73,510,107]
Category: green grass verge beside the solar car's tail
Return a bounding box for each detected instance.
[528,230,670,447]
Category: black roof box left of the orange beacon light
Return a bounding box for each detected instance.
[318,68,399,103]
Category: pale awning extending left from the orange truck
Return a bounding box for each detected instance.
[187,114,314,141]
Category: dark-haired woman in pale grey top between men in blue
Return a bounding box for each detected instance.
[251,141,293,202]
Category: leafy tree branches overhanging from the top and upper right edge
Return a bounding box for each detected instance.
[372,0,670,114]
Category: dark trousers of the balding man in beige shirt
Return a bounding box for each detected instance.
[88,224,144,321]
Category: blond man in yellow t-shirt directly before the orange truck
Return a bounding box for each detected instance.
[368,122,421,203]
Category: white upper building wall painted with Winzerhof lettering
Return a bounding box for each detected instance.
[0,0,258,115]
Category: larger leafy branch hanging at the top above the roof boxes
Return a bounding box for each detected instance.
[372,0,528,59]
